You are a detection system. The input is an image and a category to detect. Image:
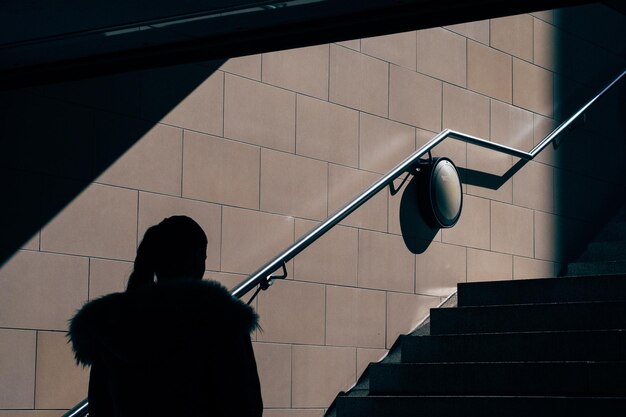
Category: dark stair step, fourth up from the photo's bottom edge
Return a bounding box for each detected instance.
[430,301,626,335]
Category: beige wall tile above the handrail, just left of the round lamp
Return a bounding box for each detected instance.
[359,113,415,174]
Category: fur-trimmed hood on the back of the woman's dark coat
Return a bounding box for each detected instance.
[68,281,258,365]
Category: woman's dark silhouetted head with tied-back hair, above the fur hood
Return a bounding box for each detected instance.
[127,216,207,290]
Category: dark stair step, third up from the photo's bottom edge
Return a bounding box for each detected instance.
[401,330,626,363]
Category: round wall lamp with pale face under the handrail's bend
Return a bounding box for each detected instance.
[417,158,463,228]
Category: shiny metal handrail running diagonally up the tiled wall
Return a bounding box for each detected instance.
[63,70,626,417]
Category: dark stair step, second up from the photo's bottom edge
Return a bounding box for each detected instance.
[369,362,626,397]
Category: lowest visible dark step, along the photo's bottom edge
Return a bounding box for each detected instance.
[337,396,626,417]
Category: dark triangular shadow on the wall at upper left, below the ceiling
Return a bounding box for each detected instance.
[0,60,225,266]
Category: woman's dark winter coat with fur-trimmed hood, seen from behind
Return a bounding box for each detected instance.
[69,281,263,417]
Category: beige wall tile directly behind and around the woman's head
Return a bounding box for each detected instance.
[137,193,222,270]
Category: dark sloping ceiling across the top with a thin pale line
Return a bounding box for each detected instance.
[0,0,604,89]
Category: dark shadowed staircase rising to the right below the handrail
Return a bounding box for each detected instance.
[329,205,626,417]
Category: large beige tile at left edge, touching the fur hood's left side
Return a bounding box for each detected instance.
[0,251,89,330]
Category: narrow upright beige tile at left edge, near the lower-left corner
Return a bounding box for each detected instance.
[0,329,37,408]
